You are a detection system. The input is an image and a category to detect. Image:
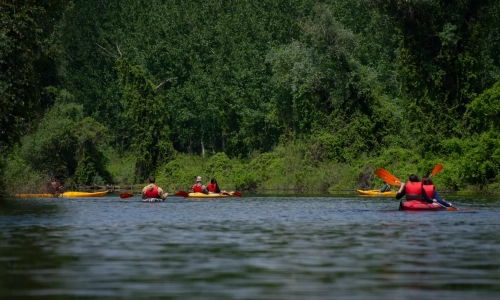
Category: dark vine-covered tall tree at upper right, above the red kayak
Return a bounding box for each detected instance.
[370,0,499,152]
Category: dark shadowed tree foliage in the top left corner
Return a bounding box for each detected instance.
[0,0,65,152]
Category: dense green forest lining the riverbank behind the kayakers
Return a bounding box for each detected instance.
[0,0,500,195]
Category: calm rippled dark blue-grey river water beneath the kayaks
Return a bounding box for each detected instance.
[0,195,500,300]
